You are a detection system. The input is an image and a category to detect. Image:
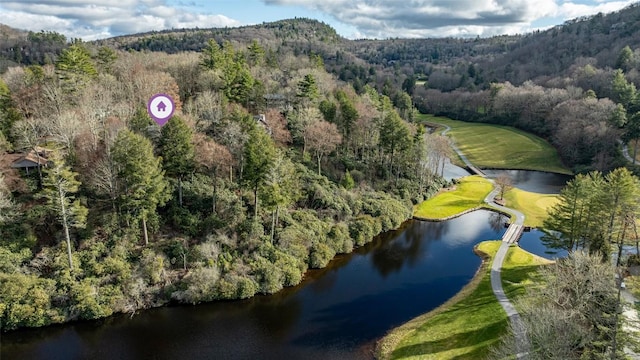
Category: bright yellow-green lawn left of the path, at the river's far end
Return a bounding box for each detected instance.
[413,175,493,220]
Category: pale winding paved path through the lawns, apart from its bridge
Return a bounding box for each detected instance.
[440,124,529,359]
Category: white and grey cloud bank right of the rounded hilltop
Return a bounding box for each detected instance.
[263,0,633,38]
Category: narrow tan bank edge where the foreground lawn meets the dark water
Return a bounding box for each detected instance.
[374,240,492,360]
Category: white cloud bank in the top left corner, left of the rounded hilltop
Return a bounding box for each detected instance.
[0,0,240,41]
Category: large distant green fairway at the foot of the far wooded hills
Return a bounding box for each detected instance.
[418,114,571,174]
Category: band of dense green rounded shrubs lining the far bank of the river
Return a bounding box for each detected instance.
[0,173,420,331]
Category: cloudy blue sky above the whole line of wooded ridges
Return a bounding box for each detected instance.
[0,0,638,41]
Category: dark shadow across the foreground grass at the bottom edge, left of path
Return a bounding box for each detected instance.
[391,318,508,359]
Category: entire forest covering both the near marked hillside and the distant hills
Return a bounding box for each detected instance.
[0,1,640,331]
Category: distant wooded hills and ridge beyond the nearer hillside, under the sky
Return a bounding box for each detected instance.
[75,4,640,172]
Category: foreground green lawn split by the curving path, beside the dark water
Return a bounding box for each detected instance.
[376,241,548,359]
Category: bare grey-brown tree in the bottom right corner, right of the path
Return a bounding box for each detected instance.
[492,251,625,360]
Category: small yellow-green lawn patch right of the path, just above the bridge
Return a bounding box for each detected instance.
[504,188,558,227]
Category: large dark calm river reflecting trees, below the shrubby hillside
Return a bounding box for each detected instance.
[2,211,506,360]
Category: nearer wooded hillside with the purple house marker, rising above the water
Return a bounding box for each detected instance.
[0,28,448,331]
